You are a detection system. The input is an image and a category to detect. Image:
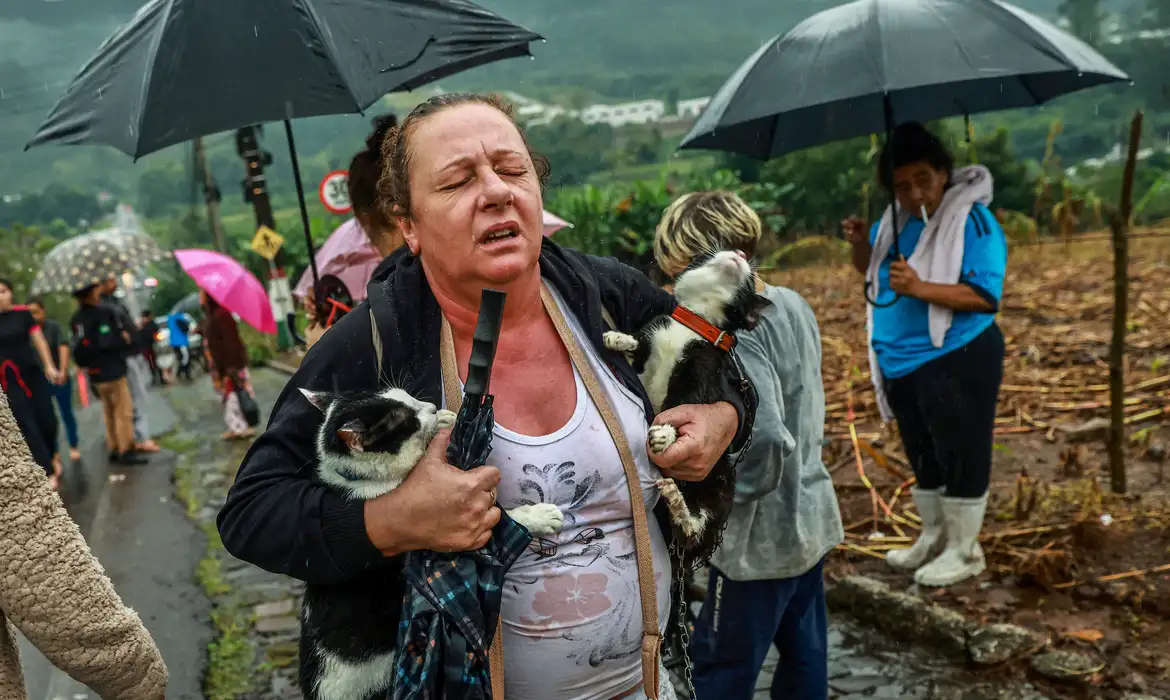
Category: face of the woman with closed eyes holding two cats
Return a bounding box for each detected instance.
[399,104,543,288]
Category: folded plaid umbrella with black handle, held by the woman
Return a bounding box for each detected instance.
[393,289,532,700]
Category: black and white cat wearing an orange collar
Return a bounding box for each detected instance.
[604,251,769,571]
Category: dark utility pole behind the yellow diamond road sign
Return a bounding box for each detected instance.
[235,126,305,350]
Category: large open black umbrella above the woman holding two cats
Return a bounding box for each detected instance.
[26,0,541,294]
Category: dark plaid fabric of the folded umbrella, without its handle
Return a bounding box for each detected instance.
[393,514,532,700]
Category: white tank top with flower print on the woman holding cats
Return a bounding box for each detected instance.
[442,286,670,700]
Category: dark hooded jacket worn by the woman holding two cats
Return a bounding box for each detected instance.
[218,239,756,585]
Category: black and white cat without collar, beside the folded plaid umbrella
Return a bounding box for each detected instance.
[301,389,564,700]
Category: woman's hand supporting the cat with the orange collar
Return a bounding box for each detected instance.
[651,402,739,481]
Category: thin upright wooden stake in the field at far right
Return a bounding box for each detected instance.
[1109,110,1143,494]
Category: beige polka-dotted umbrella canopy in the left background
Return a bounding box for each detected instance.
[32,228,171,294]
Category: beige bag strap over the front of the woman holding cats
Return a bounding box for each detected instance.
[430,288,662,700]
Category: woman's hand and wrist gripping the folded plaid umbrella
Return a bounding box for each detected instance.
[365,428,500,556]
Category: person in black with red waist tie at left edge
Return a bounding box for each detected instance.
[0,279,62,488]
